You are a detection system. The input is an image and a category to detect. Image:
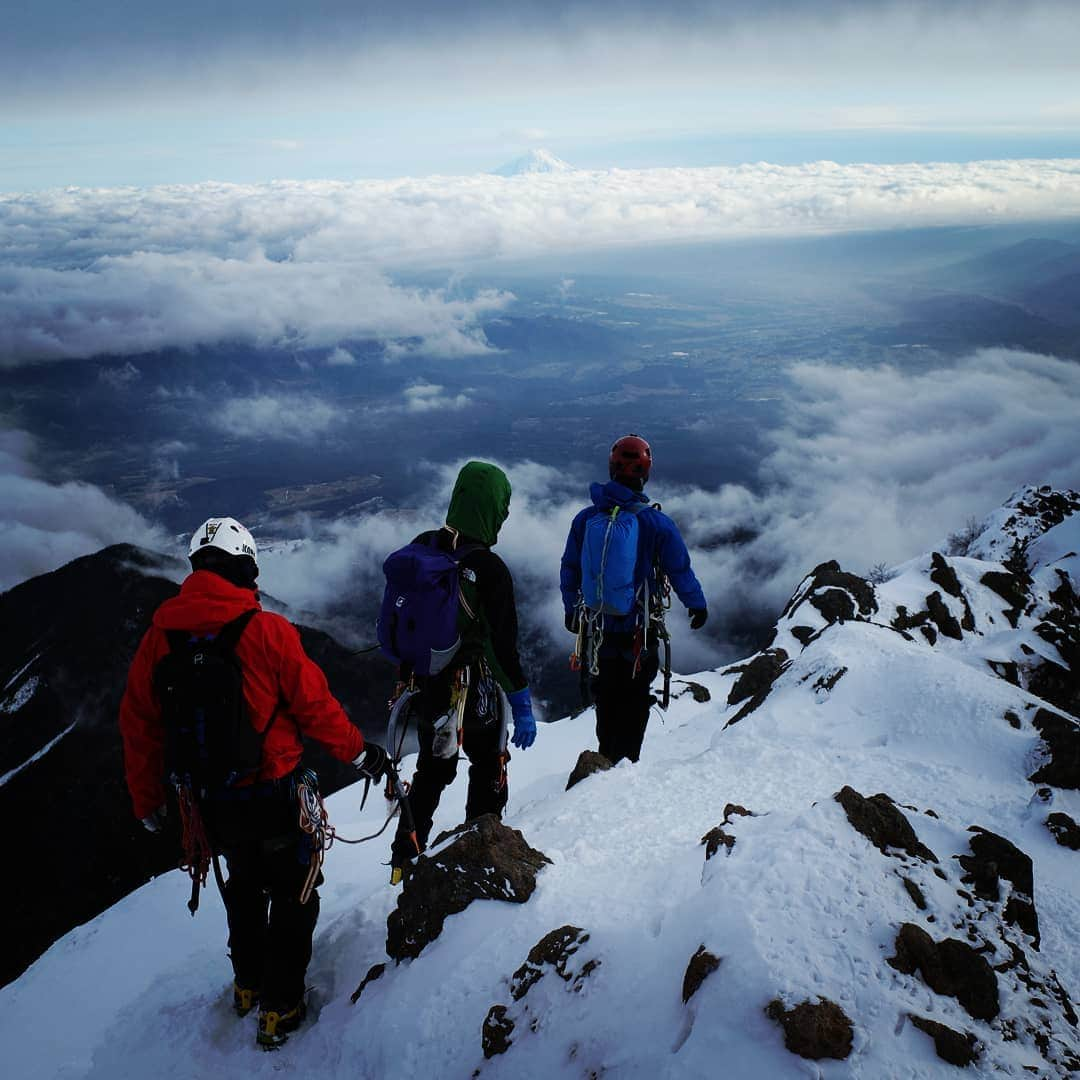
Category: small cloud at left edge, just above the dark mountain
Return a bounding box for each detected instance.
[0,430,168,590]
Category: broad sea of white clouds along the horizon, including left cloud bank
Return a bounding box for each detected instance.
[0,160,1080,366]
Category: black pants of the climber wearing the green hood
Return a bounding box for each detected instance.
[391,664,510,866]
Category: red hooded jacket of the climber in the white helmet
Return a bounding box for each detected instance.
[120,570,364,818]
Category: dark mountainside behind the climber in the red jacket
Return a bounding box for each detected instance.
[0,544,392,985]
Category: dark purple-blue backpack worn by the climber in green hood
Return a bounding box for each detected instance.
[376,541,477,676]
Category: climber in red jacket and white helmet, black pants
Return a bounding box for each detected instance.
[120,517,387,1047]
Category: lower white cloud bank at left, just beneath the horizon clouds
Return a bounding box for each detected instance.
[0,250,508,363]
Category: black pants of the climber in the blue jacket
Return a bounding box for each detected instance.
[590,634,660,764]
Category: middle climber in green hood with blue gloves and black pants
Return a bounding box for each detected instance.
[390,461,537,885]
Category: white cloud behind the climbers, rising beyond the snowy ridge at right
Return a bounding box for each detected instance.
[257,349,1080,671]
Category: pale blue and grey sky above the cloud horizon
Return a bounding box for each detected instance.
[0,0,1080,191]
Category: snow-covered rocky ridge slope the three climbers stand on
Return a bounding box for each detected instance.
[0,489,1080,1080]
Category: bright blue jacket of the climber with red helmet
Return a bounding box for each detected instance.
[559,480,706,632]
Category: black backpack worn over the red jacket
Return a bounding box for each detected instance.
[153,608,270,798]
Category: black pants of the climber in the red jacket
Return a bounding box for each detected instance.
[205,787,322,1012]
